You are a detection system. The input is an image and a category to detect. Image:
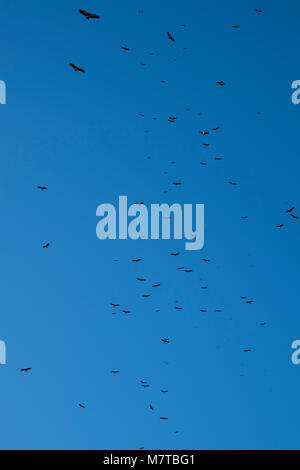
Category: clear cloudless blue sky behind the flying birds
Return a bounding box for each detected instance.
[0,0,300,449]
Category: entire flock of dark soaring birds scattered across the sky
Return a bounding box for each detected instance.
[17,8,299,449]
